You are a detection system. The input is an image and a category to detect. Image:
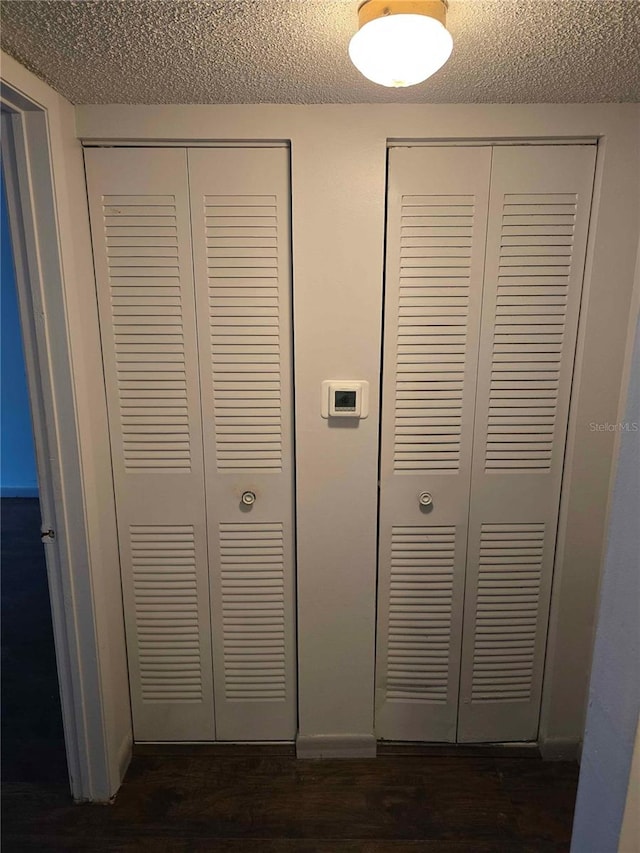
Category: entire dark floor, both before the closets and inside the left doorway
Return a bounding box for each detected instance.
[2,500,578,853]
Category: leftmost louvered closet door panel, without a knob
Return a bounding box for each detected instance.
[85,148,215,740]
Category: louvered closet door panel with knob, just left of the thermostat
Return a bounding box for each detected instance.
[189,148,297,740]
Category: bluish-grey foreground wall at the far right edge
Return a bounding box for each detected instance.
[571,233,640,853]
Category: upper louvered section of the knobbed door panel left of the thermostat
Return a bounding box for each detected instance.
[204,187,282,473]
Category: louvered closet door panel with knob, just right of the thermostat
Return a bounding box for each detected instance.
[376,147,491,741]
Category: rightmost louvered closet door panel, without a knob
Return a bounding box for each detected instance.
[458,146,595,741]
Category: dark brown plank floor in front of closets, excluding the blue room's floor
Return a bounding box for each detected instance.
[3,750,577,853]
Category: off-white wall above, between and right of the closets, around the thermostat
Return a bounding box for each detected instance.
[76,104,638,755]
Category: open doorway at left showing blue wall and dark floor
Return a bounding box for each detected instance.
[0,160,68,784]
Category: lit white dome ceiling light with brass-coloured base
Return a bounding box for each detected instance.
[349,0,453,87]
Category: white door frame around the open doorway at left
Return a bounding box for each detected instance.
[0,78,120,801]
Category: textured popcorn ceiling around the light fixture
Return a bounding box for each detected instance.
[0,0,640,104]
